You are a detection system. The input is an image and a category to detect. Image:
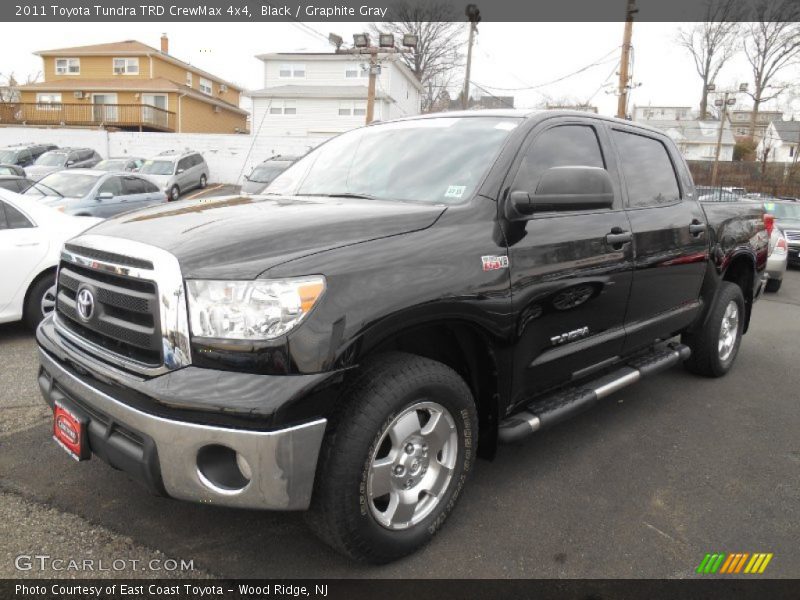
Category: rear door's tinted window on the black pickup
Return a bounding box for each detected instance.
[614,131,681,207]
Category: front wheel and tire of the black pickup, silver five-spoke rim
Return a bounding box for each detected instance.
[307,352,478,564]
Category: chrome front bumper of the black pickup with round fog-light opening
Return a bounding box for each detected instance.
[39,348,326,510]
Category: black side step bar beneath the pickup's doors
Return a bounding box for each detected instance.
[497,344,692,444]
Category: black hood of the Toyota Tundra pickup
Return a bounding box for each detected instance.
[91,196,446,279]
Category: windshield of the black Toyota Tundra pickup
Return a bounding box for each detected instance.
[267,117,520,203]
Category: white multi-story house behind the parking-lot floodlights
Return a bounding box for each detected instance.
[247,52,422,137]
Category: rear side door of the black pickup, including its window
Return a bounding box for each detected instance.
[611,126,708,352]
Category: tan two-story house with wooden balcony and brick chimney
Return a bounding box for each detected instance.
[7,35,247,133]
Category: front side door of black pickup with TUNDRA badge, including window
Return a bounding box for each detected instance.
[500,119,633,404]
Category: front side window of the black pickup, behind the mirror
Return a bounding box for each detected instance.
[513,125,605,193]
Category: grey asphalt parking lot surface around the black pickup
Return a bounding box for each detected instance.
[0,269,800,578]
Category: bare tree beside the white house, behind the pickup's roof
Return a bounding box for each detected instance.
[371,0,465,112]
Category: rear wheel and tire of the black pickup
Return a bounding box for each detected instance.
[681,281,745,377]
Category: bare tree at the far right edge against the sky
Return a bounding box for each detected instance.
[744,0,800,137]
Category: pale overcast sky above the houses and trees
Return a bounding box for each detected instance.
[0,23,800,118]
